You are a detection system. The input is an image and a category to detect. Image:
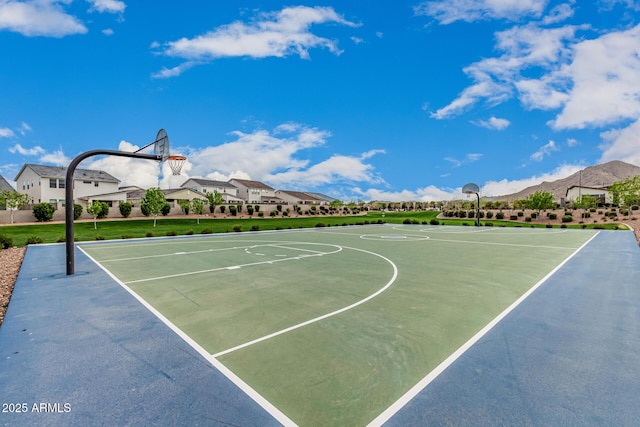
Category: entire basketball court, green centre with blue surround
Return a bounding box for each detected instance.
[0,225,640,426]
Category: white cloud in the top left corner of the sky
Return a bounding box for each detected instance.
[0,0,88,37]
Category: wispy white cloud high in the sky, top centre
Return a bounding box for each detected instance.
[156,6,357,75]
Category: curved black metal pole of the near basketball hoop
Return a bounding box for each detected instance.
[64,150,162,276]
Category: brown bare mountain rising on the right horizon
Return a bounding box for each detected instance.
[490,160,640,201]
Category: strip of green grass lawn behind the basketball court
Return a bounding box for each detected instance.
[0,211,626,247]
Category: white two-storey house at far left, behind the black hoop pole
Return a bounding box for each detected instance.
[15,164,120,206]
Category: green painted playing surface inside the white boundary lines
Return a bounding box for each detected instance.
[80,225,596,425]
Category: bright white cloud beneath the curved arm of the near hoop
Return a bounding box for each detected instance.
[83,141,161,188]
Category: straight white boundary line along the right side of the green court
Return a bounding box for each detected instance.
[368,231,600,427]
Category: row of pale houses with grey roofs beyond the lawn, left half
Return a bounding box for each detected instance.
[0,164,335,211]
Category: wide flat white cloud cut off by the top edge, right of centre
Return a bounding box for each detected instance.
[414,0,548,25]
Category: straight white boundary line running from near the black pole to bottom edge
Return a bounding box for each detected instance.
[77,246,297,426]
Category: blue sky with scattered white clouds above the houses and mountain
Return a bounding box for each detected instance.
[0,0,640,201]
